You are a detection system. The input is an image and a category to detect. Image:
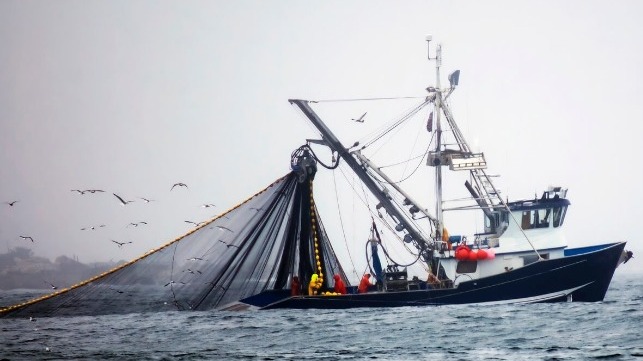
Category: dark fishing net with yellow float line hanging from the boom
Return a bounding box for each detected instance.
[0,165,348,317]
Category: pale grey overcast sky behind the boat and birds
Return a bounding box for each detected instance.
[0,0,643,272]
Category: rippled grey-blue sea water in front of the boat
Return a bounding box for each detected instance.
[0,272,643,360]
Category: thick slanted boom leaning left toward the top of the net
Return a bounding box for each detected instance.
[288,99,433,260]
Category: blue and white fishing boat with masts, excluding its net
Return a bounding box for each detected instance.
[248,37,632,309]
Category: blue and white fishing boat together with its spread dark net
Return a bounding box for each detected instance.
[0,37,632,317]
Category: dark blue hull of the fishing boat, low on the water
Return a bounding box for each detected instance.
[253,242,625,309]
